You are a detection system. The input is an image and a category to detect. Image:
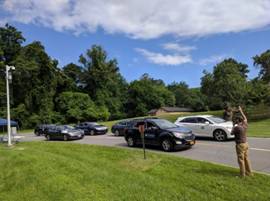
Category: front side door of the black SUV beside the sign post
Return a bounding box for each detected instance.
[144,121,159,145]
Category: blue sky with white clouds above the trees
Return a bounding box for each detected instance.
[0,0,270,87]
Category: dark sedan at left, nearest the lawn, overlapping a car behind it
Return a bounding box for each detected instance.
[45,125,84,141]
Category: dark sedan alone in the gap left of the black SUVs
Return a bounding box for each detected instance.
[76,122,108,135]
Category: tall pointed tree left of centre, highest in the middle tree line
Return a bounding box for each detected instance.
[80,45,127,119]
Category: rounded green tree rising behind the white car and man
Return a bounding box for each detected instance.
[201,59,248,109]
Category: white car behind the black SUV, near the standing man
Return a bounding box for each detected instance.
[175,115,234,141]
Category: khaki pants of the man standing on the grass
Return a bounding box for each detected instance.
[236,143,252,177]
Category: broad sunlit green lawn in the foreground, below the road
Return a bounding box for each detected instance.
[0,142,270,201]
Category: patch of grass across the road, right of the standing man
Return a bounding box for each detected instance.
[248,119,270,137]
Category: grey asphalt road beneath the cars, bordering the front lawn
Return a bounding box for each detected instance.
[21,134,270,174]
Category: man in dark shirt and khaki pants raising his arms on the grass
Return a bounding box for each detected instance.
[232,106,253,177]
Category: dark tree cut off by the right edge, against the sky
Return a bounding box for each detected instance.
[253,50,270,83]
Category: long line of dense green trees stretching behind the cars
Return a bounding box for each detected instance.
[0,25,270,127]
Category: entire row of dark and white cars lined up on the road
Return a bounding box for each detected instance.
[35,115,234,151]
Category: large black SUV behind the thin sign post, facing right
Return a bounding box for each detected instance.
[125,118,195,151]
